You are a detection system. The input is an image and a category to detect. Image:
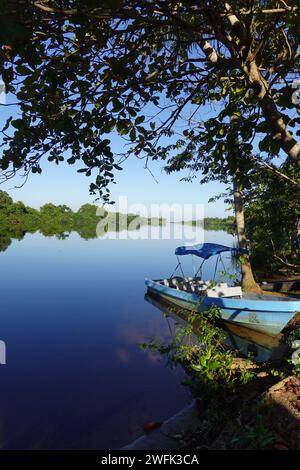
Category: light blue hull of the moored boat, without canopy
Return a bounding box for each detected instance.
[146,279,300,335]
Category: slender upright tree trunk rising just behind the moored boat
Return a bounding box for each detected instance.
[233,180,263,294]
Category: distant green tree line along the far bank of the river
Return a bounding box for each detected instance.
[0,191,231,251]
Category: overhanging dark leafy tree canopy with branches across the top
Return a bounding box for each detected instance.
[0,0,300,201]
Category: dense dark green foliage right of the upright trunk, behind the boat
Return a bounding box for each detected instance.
[245,165,300,272]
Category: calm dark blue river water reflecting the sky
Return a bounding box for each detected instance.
[0,232,233,449]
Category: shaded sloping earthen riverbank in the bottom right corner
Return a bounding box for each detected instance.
[123,359,300,450]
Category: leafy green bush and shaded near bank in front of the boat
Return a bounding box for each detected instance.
[141,307,300,450]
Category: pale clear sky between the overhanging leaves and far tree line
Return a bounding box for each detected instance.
[0,92,231,217]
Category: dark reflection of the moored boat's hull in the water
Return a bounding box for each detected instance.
[145,292,289,362]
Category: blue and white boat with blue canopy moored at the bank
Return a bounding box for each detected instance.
[145,243,300,335]
